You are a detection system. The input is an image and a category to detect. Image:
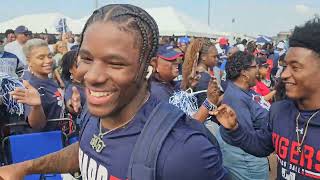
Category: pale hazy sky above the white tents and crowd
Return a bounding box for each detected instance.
[0,0,320,36]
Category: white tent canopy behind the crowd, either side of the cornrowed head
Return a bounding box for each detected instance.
[0,7,227,37]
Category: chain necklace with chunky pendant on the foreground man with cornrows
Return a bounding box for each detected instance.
[90,94,150,153]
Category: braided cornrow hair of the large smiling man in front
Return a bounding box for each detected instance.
[80,4,159,81]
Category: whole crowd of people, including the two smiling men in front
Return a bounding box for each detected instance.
[0,2,320,180]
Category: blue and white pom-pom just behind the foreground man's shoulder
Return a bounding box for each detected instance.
[169,89,207,116]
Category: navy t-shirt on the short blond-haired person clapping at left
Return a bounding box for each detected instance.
[23,71,64,131]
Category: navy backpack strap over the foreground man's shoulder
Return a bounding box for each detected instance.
[127,103,219,180]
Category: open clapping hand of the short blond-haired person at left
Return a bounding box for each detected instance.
[10,81,41,106]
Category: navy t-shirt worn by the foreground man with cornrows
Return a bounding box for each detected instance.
[79,96,226,180]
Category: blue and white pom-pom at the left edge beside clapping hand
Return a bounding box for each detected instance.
[0,73,24,115]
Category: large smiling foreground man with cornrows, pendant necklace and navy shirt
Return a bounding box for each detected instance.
[0,4,230,180]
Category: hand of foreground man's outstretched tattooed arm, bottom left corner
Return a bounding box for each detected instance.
[0,165,26,180]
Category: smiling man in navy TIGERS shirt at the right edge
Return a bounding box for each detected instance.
[214,18,320,180]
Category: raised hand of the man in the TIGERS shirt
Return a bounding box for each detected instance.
[209,104,238,131]
